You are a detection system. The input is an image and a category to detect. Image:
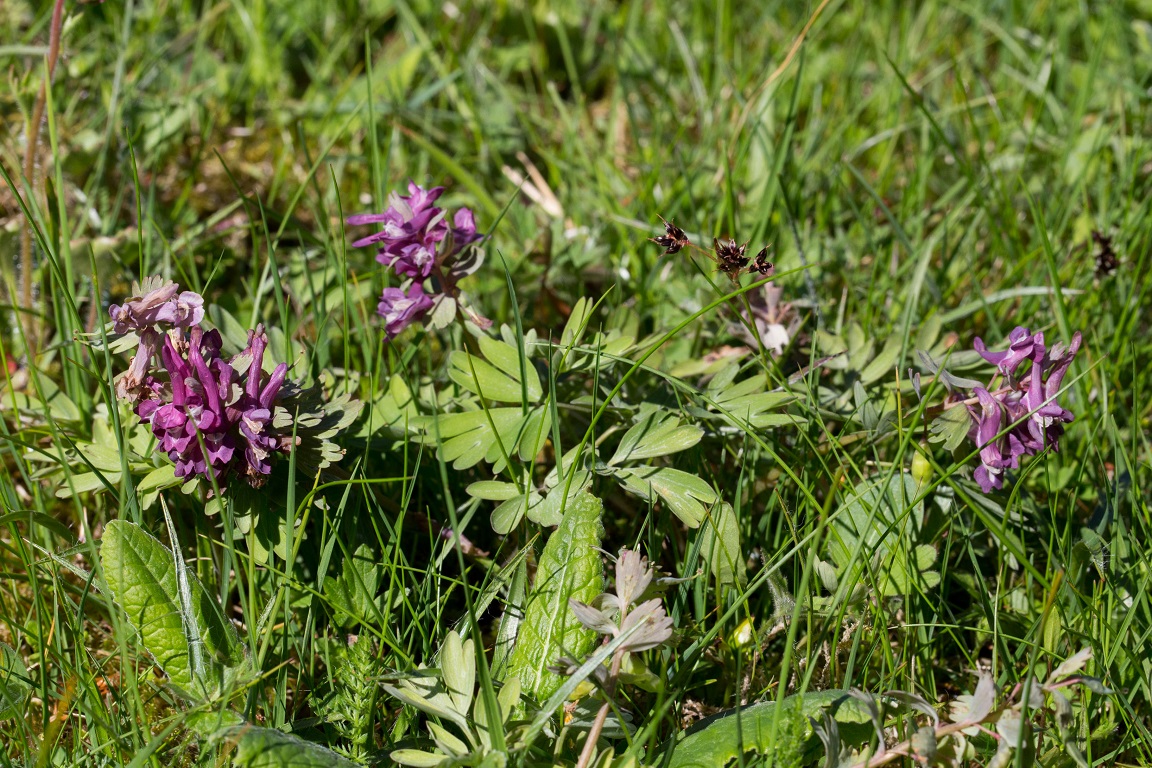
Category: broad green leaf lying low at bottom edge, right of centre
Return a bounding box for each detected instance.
[655,691,872,768]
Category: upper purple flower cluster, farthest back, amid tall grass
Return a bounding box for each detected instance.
[348,182,482,340]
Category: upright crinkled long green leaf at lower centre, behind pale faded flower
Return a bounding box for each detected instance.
[509,491,604,701]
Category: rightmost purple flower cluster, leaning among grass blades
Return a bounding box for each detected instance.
[968,327,1081,493]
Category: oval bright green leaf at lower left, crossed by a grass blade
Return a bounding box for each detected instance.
[100,520,248,698]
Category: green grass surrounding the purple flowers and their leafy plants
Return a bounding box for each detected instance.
[0,0,1152,765]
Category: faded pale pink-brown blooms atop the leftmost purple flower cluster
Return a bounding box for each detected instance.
[108,277,204,400]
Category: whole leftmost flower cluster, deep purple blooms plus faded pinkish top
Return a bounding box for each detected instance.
[109,279,291,487]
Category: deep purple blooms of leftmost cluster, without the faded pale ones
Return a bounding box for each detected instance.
[136,327,290,487]
